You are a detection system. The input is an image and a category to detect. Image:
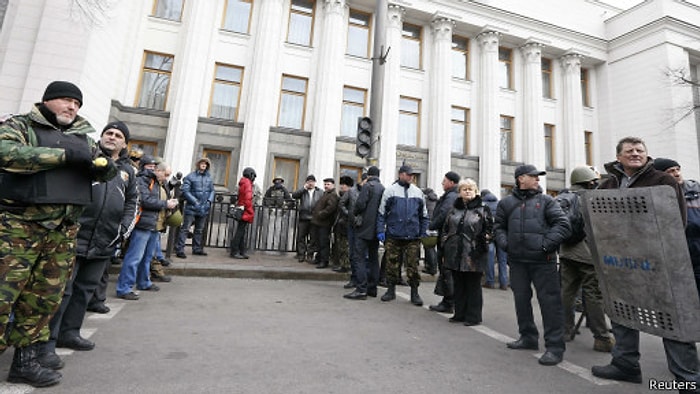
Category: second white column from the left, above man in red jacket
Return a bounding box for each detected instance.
[236,0,285,184]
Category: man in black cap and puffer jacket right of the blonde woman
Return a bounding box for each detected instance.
[494,164,571,365]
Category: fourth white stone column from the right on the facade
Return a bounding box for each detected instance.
[428,17,455,190]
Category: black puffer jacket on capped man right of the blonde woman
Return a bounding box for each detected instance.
[494,187,571,263]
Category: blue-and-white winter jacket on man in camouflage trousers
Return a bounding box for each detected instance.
[377,181,430,240]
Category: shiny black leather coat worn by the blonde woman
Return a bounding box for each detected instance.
[442,196,493,272]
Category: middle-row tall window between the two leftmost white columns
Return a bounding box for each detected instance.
[209,64,243,120]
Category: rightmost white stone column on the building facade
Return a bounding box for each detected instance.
[560,53,587,185]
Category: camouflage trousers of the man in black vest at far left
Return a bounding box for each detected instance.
[0,213,78,351]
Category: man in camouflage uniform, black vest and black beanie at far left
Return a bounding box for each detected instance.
[0,81,117,387]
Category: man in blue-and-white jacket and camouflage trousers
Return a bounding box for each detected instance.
[377,165,429,306]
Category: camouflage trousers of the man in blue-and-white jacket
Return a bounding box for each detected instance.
[384,238,421,287]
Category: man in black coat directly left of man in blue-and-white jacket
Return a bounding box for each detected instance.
[343,166,384,300]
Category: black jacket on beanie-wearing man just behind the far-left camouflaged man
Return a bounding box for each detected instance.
[76,151,139,259]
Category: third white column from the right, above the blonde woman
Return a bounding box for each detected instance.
[475,31,501,196]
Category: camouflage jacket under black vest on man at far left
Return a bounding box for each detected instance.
[0,104,116,228]
